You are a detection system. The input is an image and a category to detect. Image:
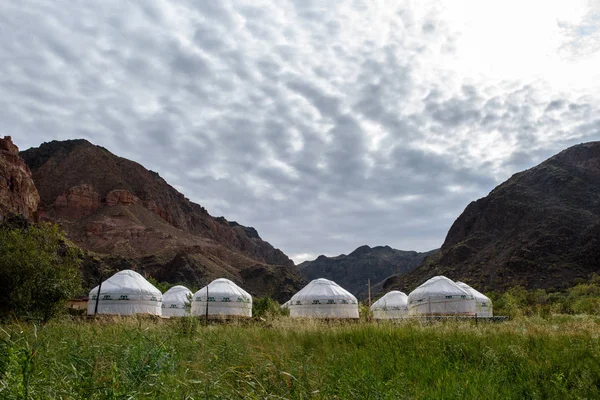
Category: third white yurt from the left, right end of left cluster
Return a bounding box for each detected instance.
[192,278,252,317]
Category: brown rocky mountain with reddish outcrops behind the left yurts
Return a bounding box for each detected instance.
[20,140,304,299]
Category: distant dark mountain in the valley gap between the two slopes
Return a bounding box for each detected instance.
[298,246,437,299]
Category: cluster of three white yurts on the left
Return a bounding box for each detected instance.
[87,270,252,317]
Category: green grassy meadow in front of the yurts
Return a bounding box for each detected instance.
[0,316,600,399]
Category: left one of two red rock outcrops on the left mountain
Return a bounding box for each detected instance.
[54,184,100,220]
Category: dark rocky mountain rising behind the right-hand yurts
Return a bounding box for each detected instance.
[384,142,600,290]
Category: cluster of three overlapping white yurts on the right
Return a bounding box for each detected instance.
[371,276,493,319]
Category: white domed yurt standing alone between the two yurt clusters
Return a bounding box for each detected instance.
[288,278,358,318]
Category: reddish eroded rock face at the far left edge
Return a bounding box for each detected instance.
[0,136,40,222]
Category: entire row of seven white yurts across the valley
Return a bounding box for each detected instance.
[88,270,493,319]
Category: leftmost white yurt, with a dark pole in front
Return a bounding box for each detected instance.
[88,269,162,315]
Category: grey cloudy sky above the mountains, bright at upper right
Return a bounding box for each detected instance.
[0,0,600,262]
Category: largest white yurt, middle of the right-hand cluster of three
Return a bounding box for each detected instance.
[408,276,475,317]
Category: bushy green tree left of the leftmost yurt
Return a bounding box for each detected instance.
[0,224,81,322]
